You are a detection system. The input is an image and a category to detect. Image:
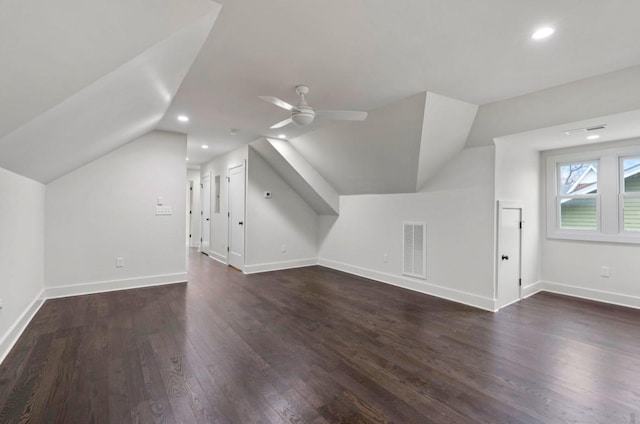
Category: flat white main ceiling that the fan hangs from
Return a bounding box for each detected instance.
[160,0,640,163]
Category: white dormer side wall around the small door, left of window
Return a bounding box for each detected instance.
[495,139,542,295]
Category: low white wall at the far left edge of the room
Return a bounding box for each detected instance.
[0,168,45,360]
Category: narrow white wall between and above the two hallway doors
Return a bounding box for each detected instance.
[200,146,249,263]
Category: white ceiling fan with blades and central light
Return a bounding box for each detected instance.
[259,85,367,129]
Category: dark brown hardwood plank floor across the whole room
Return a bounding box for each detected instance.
[0,252,640,424]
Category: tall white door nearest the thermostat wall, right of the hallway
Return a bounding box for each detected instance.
[228,165,245,270]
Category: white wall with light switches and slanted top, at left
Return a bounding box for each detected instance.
[45,131,186,296]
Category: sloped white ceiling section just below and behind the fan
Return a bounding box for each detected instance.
[290,93,426,194]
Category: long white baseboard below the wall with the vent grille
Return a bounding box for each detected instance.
[318,258,496,312]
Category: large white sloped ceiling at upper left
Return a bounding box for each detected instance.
[0,0,220,183]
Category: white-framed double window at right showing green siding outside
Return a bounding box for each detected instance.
[545,141,640,244]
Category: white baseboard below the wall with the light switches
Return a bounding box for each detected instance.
[45,272,187,299]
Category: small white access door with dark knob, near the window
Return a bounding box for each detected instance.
[497,202,522,308]
